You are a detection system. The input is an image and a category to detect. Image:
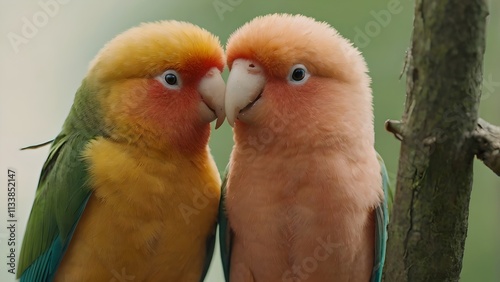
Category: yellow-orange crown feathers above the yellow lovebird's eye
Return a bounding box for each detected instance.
[88,21,224,81]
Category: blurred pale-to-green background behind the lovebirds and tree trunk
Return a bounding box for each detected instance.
[0,0,500,282]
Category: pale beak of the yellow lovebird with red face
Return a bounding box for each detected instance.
[198,67,226,129]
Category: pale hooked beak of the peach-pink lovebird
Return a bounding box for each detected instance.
[225,59,266,126]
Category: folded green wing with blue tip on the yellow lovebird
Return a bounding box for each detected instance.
[17,135,94,281]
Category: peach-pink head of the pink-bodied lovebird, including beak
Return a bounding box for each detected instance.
[225,14,373,144]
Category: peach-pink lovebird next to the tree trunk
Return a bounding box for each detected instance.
[220,14,389,282]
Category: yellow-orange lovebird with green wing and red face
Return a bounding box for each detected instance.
[17,21,225,282]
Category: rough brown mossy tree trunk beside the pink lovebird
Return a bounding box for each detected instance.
[384,0,487,282]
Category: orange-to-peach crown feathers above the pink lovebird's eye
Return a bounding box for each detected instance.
[226,14,367,81]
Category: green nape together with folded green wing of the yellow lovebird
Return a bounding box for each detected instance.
[17,80,105,282]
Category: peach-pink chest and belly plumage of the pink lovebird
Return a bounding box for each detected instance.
[226,149,380,281]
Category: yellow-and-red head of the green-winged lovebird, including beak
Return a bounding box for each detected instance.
[85,21,225,153]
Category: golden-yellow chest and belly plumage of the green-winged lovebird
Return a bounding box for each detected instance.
[56,140,220,281]
